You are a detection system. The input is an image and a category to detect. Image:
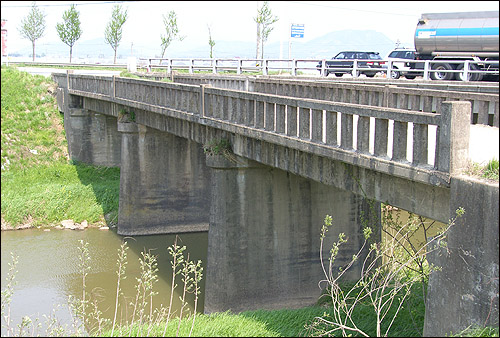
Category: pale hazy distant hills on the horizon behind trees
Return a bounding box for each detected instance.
[9,30,412,62]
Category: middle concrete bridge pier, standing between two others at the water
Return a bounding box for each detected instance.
[118,122,210,235]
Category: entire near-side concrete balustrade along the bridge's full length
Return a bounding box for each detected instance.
[56,74,470,184]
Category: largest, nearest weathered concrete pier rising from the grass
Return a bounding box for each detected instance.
[205,155,380,313]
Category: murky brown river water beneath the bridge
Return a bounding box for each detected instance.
[1,228,208,336]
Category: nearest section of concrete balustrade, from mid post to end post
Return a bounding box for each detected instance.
[203,87,441,170]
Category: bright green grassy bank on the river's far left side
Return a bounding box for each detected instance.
[1,66,120,229]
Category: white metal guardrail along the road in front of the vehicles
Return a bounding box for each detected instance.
[139,58,499,81]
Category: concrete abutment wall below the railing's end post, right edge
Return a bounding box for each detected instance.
[424,176,499,337]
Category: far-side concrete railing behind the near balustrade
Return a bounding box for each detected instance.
[170,74,500,127]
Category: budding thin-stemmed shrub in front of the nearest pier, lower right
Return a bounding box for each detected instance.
[307,209,464,337]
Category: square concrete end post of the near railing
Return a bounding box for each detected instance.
[434,101,472,175]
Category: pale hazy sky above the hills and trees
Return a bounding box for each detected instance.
[1,1,499,57]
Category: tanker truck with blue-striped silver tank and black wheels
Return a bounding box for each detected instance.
[410,11,498,81]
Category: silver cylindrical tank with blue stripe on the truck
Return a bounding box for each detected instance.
[415,11,499,57]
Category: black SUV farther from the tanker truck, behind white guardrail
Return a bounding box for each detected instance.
[316,51,385,77]
